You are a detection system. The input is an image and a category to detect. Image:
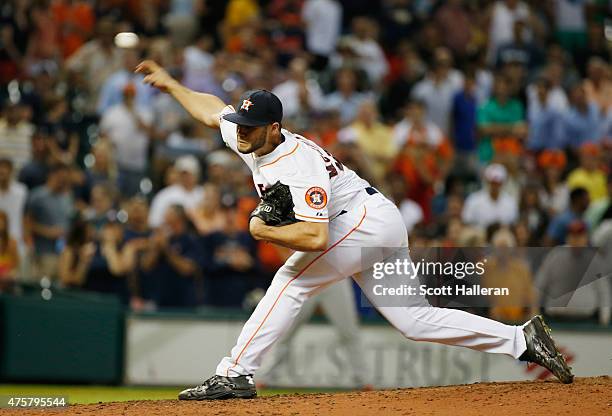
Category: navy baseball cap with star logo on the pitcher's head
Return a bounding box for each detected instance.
[223,90,283,127]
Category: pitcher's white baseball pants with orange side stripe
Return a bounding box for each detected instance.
[216,191,526,377]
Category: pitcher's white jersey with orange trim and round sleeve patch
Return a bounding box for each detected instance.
[220,106,370,222]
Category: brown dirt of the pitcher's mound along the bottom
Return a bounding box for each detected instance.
[0,376,612,416]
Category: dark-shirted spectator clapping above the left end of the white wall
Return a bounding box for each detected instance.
[142,205,203,308]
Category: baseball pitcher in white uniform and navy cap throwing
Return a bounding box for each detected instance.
[136,61,573,400]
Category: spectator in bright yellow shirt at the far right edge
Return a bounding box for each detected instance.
[567,143,608,203]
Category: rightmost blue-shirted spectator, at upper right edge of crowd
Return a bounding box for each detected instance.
[562,84,602,148]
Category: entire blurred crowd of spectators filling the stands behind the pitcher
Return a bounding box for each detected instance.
[0,0,612,323]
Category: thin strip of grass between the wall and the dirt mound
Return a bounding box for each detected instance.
[0,384,330,404]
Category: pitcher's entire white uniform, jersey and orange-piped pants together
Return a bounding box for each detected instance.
[216,106,526,384]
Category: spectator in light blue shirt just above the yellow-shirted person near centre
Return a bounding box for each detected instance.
[323,67,368,125]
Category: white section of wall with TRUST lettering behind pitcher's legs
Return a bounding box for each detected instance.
[125,316,612,388]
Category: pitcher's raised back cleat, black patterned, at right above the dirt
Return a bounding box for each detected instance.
[519,315,574,384]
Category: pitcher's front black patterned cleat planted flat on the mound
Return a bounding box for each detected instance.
[179,375,257,400]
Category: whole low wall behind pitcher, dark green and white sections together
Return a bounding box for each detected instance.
[0,292,612,388]
